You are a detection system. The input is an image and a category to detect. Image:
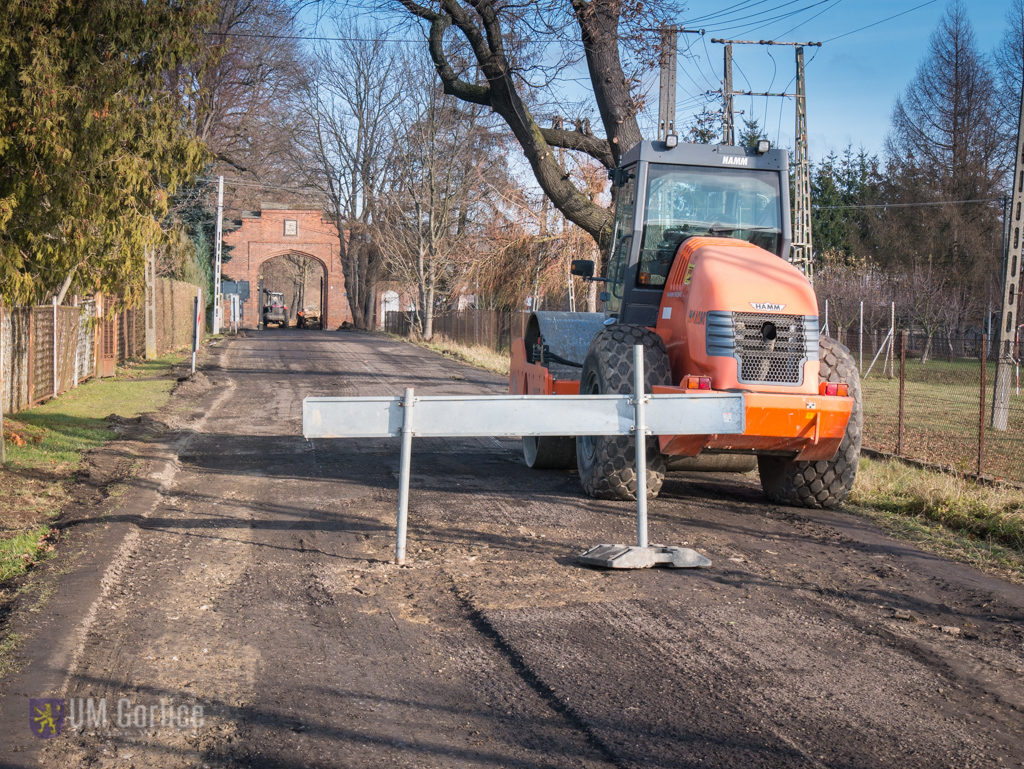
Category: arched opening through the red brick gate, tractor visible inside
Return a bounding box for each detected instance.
[257,251,329,329]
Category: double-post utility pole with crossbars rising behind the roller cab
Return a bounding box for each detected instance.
[712,38,821,281]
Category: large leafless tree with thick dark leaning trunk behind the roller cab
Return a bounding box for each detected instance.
[394,0,675,249]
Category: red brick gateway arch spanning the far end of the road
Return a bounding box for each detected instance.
[224,204,352,329]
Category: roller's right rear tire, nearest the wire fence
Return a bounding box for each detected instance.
[758,337,864,508]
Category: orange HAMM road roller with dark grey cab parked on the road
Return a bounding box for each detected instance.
[509,141,861,507]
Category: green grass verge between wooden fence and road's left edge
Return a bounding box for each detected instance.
[0,353,183,583]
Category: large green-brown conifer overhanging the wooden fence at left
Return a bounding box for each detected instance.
[0,0,211,302]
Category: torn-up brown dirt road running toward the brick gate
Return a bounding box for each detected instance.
[0,331,1024,768]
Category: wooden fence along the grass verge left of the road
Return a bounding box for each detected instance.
[0,279,198,414]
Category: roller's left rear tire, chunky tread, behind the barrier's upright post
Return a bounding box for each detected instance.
[575,324,672,500]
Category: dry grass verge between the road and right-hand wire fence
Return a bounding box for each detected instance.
[849,458,1024,582]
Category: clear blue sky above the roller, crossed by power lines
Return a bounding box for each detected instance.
[644,0,1010,161]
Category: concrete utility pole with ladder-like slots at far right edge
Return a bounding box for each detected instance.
[992,75,1024,430]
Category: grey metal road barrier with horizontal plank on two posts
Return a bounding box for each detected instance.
[302,346,745,568]
